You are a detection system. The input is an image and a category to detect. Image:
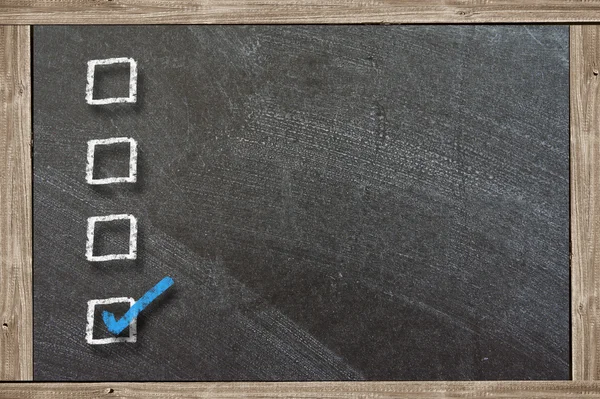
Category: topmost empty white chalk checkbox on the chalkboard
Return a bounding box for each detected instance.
[85,57,137,105]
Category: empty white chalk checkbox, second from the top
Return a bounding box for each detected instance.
[85,137,137,185]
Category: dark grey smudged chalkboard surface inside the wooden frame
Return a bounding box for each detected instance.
[33,26,570,381]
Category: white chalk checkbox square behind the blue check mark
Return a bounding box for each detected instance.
[85,297,137,345]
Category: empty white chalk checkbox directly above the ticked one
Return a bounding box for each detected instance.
[85,214,137,262]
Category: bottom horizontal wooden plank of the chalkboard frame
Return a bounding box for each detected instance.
[0,381,600,399]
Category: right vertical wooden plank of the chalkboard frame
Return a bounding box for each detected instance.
[571,26,600,380]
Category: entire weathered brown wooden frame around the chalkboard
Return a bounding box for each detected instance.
[0,0,600,399]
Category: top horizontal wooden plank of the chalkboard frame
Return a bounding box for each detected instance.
[0,0,600,24]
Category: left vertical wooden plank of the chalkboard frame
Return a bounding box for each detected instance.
[0,26,33,380]
